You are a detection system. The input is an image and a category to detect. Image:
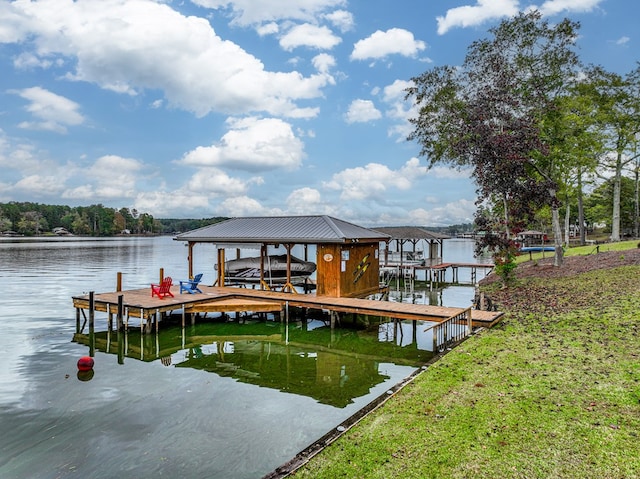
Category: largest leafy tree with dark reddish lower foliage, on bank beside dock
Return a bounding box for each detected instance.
[407,11,579,266]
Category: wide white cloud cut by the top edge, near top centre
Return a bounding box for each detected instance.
[192,0,347,26]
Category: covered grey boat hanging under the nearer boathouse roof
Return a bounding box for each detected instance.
[224,254,316,282]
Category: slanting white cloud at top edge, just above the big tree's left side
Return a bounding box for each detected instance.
[436,0,519,35]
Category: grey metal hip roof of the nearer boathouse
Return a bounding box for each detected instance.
[174,215,390,244]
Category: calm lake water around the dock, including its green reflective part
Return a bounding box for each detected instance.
[0,237,488,479]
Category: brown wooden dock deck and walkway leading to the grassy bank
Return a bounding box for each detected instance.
[73,284,502,327]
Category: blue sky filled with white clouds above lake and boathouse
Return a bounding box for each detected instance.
[0,0,640,227]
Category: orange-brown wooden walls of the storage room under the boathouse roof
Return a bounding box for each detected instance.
[316,243,380,298]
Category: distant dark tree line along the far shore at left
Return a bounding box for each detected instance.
[0,201,224,236]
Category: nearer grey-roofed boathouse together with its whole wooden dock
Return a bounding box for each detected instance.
[73,215,500,332]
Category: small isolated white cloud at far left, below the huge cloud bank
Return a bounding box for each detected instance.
[14,87,84,133]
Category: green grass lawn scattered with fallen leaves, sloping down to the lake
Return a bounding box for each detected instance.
[295,255,640,479]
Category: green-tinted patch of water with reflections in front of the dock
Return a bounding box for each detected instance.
[74,318,433,408]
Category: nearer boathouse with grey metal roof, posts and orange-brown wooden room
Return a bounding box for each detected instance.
[174,215,390,298]
